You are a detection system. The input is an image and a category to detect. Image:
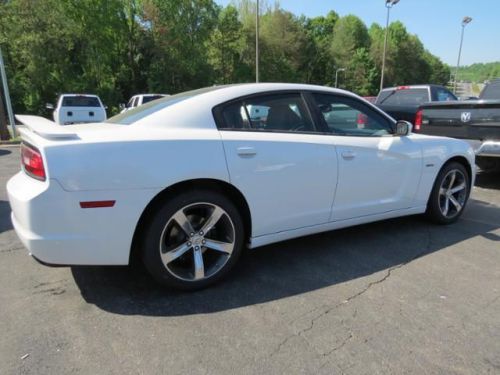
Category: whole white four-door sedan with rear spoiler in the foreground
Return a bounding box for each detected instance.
[7,84,475,290]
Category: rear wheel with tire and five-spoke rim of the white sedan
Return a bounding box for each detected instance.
[141,190,245,291]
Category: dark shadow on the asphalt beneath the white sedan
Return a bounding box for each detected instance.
[72,200,500,316]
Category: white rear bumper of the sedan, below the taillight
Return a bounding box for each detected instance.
[7,172,156,265]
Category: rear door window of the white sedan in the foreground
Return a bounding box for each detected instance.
[220,93,315,132]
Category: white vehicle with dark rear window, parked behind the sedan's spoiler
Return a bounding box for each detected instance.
[46,94,106,125]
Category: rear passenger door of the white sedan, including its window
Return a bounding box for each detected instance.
[214,92,337,236]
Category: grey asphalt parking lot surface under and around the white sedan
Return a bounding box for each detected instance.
[0,147,500,374]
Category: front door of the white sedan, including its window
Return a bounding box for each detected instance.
[313,93,422,221]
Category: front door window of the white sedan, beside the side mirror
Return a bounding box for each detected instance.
[313,94,393,137]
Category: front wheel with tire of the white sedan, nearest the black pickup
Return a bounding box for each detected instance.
[425,162,471,224]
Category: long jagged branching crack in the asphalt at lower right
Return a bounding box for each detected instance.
[270,228,432,357]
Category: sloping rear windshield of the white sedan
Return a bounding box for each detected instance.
[106,86,228,125]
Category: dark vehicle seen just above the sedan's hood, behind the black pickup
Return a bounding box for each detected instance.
[375,85,457,123]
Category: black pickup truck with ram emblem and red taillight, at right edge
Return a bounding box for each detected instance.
[413,78,500,170]
